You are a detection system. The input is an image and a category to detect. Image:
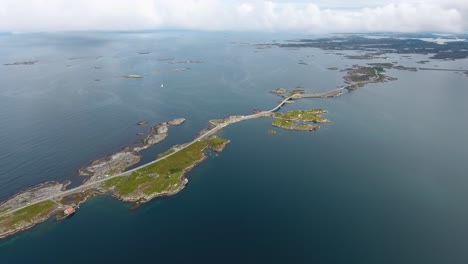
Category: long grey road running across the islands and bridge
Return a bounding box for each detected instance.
[0,88,344,217]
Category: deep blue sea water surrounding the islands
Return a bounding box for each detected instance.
[0,32,468,264]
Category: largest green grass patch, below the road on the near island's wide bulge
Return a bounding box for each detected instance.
[103,137,227,196]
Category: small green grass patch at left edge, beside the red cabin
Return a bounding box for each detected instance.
[0,201,57,226]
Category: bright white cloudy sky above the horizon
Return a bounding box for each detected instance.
[0,0,468,33]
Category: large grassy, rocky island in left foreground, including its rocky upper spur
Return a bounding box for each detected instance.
[0,118,229,238]
